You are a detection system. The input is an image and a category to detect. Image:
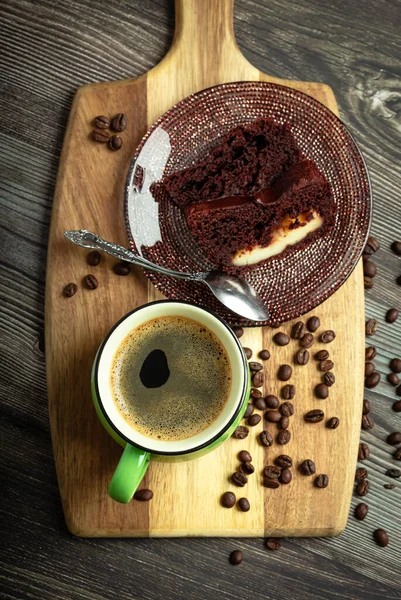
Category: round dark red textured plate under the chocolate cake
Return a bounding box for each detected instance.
[125,82,372,325]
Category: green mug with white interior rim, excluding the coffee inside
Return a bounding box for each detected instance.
[91,300,250,503]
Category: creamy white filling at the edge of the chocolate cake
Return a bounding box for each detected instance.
[232,211,323,267]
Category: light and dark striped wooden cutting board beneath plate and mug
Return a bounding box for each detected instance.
[46,0,364,536]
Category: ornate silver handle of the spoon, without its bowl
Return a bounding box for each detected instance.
[64,229,205,281]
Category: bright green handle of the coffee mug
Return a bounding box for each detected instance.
[109,444,150,504]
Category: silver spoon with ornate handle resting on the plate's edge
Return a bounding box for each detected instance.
[64,229,269,321]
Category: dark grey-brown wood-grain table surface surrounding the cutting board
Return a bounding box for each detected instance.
[0,0,401,600]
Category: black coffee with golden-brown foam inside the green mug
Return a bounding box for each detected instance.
[111,317,231,441]
